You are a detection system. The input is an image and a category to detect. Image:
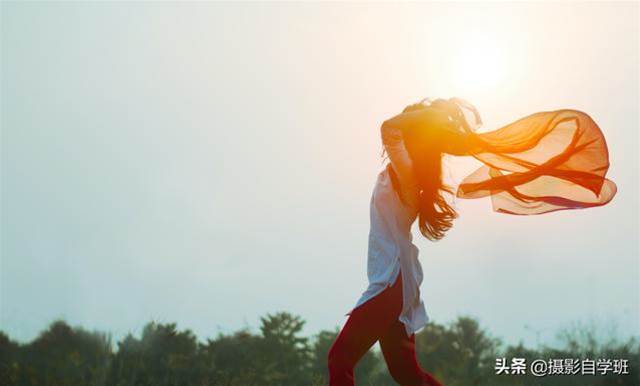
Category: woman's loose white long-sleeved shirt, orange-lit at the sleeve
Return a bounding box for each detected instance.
[347,127,429,336]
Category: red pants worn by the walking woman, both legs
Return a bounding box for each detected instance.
[328,273,442,386]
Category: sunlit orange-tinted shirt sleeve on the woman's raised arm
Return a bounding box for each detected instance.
[381,126,418,207]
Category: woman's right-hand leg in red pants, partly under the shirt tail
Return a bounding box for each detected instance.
[380,319,442,386]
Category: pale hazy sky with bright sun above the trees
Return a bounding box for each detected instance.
[0,2,640,345]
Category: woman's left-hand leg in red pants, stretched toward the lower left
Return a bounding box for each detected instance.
[328,274,402,386]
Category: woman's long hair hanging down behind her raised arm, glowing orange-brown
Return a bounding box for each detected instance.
[392,99,458,241]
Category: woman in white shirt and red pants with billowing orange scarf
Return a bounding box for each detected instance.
[328,98,616,386]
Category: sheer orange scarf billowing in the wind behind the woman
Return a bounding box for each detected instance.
[442,98,616,215]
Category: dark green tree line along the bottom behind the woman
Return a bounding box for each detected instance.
[0,312,640,386]
